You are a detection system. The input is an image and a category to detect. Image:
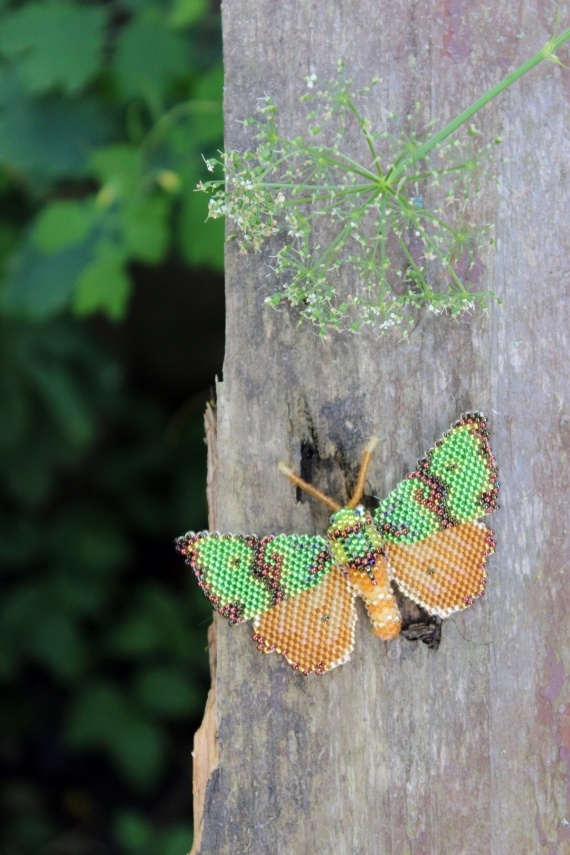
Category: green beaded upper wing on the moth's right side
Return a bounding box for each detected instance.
[373,413,498,544]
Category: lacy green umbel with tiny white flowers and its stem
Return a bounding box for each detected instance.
[199,30,570,336]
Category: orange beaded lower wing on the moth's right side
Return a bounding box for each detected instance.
[385,522,495,618]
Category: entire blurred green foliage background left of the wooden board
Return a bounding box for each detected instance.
[0,0,223,855]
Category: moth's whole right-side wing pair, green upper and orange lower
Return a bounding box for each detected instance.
[373,413,499,618]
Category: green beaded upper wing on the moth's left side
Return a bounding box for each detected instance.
[176,532,334,623]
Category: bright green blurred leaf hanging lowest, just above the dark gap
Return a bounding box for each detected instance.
[73,244,132,321]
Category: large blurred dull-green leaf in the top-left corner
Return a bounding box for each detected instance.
[0,0,106,93]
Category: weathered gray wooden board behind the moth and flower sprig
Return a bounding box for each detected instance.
[195,0,570,855]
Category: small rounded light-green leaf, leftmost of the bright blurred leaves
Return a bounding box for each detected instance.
[32,200,96,253]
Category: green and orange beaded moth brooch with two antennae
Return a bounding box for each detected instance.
[176,413,499,674]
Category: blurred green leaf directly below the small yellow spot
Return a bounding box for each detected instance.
[120,196,170,264]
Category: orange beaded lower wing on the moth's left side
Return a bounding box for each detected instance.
[253,567,357,674]
